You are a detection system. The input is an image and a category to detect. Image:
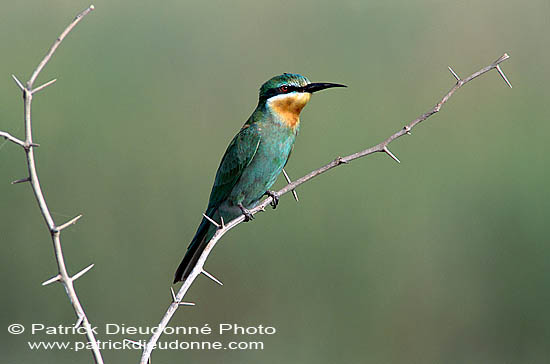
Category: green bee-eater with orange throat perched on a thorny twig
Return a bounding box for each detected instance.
[174,73,346,283]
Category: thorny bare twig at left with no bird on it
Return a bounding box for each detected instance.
[0,5,103,364]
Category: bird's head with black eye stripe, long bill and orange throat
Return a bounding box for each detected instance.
[260,73,346,129]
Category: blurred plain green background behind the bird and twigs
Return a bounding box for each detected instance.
[0,0,550,363]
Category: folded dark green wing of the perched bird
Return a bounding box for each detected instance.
[208,124,261,210]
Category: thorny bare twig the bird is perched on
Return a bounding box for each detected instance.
[140,53,511,364]
